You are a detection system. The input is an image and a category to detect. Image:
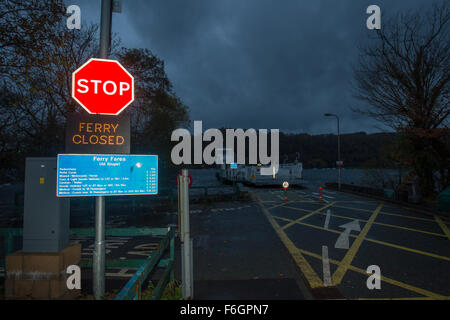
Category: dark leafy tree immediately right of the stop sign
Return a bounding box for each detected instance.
[117,48,189,184]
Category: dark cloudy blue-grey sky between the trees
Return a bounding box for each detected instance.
[66,0,440,134]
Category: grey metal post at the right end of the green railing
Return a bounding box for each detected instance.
[181,169,193,300]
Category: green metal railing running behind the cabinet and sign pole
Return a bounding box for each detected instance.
[0,228,175,300]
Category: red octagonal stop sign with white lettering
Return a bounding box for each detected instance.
[72,58,134,115]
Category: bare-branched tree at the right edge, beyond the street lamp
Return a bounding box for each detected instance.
[354,1,450,195]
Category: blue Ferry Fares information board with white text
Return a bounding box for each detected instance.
[56,154,158,197]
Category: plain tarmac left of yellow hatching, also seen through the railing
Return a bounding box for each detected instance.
[68,201,310,300]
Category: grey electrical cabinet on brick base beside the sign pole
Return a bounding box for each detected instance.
[23,158,70,252]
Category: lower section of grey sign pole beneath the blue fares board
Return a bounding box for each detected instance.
[93,196,105,300]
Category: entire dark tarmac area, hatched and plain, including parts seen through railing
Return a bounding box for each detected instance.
[1,185,450,299]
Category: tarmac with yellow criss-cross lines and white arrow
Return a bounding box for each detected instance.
[253,182,450,299]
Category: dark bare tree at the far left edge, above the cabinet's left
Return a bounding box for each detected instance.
[0,0,65,181]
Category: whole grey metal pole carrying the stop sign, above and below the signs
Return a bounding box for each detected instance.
[92,0,112,300]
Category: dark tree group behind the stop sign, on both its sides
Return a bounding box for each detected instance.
[0,0,188,181]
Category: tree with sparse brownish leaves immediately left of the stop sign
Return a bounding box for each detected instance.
[0,17,98,160]
